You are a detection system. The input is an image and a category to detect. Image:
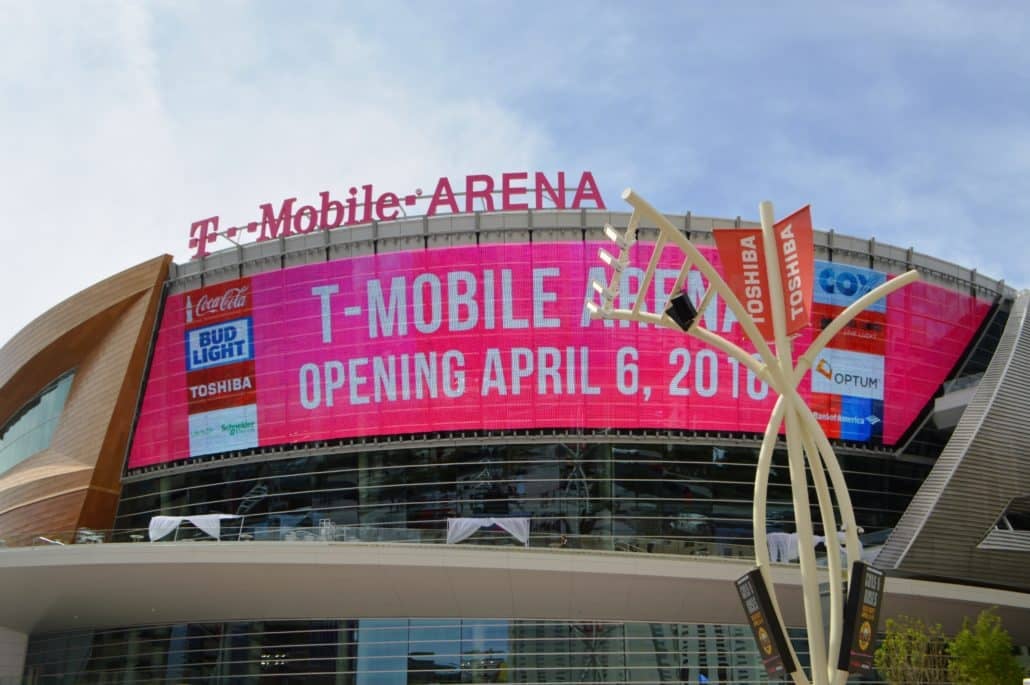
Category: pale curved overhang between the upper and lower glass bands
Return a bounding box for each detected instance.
[0,541,1030,644]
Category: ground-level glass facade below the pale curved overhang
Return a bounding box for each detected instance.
[26,619,819,685]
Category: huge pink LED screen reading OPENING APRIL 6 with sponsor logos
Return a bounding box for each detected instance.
[129,243,989,469]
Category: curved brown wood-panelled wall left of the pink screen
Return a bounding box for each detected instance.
[0,255,171,545]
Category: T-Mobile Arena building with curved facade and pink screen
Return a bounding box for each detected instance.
[0,174,1030,684]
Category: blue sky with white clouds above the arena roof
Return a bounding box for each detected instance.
[0,0,1030,348]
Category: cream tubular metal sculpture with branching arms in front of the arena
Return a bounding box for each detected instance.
[587,190,919,685]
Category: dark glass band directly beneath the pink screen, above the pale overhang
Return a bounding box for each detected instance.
[116,443,930,556]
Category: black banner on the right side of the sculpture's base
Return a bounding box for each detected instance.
[837,561,886,673]
